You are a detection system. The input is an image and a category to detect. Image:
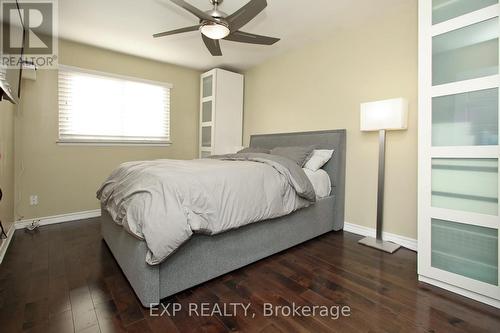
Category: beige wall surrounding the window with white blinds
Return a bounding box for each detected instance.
[16,41,200,219]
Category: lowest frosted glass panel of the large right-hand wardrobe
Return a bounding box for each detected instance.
[431,219,498,285]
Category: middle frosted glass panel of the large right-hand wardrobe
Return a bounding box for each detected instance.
[432,88,498,146]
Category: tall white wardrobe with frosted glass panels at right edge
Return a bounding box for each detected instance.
[419,0,500,304]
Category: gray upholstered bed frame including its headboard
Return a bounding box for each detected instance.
[101,130,346,307]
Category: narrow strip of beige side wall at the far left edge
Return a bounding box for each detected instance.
[0,101,15,231]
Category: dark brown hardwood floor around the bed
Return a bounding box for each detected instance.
[0,219,500,333]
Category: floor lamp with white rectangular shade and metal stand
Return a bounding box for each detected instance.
[359,98,408,253]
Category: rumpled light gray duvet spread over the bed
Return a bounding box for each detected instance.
[97,154,314,265]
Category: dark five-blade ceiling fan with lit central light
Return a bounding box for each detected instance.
[153,0,280,56]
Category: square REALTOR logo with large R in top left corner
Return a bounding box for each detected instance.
[0,0,58,68]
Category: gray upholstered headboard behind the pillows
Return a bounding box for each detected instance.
[250,129,346,221]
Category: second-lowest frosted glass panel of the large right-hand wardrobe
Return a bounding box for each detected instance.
[432,158,498,215]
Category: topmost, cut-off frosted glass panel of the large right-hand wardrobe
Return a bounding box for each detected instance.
[432,0,498,24]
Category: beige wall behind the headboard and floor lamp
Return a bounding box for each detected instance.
[244,0,417,238]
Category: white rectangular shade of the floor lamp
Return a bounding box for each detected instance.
[360,98,408,131]
